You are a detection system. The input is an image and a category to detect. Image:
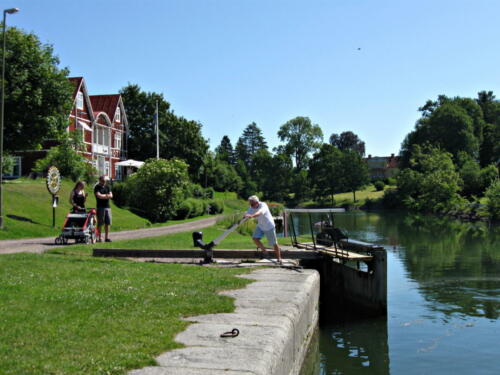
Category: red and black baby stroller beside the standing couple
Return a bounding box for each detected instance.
[55,208,98,245]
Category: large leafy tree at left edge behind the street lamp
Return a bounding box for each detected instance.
[0,27,74,151]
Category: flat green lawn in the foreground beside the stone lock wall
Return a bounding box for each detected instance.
[0,254,248,375]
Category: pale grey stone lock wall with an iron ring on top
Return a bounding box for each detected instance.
[129,268,320,375]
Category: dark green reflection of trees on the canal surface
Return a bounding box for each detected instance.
[337,213,500,319]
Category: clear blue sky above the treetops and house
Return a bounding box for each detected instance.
[6,0,500,156]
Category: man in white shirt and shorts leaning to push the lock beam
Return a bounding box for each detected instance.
[245,195,281,263]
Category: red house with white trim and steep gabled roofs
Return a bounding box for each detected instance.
[14,77,128,180]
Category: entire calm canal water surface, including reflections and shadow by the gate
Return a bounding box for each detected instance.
[303,212,500,375]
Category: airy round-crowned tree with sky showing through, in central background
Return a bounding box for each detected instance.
[278,116,323,171]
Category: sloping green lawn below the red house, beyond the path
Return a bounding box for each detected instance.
[0,178,246,240]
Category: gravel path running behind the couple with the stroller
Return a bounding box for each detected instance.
[0,216,220,254]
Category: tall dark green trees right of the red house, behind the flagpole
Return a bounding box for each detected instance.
[120,84,208,180]
